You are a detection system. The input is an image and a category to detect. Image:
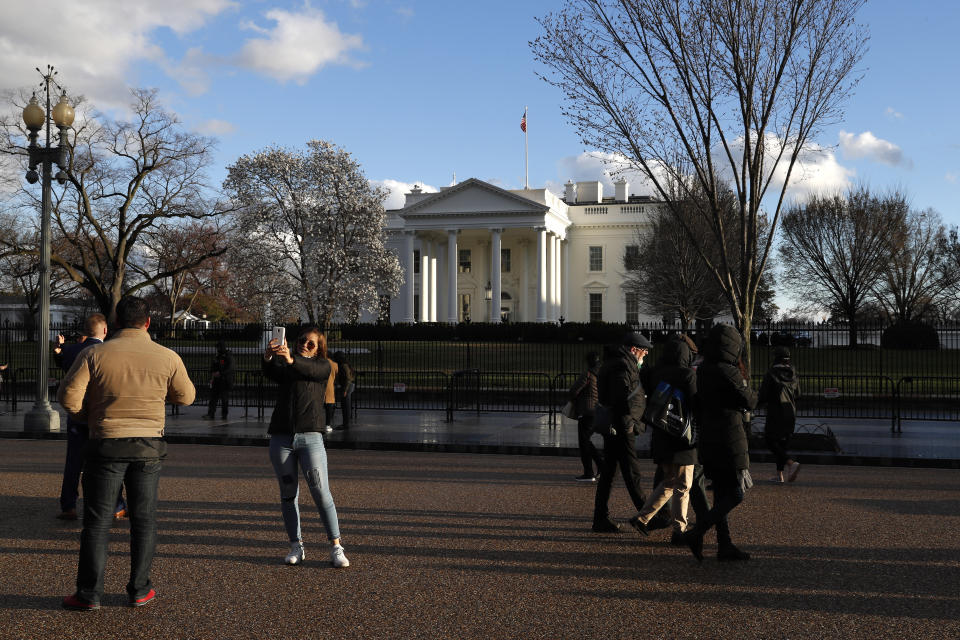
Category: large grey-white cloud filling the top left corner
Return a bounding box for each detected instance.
[0,0,237,108]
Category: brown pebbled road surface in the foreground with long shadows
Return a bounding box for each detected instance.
[0,416,960,639]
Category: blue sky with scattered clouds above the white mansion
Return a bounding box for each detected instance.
[0,0,960,224]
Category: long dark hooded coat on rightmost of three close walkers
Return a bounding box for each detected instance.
[697,324,757,469]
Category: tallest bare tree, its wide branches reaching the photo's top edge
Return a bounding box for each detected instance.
[531,0,866,370]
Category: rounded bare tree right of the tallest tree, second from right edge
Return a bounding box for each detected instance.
[780,186,909,346]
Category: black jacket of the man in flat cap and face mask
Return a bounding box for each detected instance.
[597,346,647,435]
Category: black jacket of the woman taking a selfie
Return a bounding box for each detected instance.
[261,355,331,435]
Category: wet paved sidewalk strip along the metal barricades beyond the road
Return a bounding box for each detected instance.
[0,403,960,469]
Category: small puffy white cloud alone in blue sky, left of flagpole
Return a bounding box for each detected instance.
[235,5,364,84]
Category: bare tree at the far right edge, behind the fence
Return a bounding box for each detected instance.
[874,209,960,323]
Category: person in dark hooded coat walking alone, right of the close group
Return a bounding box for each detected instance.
[757,347,800,484]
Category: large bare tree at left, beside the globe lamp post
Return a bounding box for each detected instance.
[0,89,231,318]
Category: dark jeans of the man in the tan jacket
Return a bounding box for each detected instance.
[77,456,161,603]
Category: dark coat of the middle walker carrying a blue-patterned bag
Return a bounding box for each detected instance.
[645,340,697,465]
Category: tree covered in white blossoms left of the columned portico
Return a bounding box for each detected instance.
[224,140,403,326]
